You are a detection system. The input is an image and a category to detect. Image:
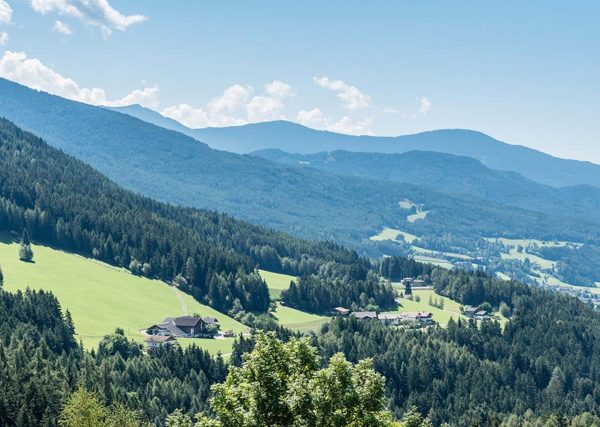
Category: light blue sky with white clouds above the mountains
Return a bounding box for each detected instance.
[0,0,600,162]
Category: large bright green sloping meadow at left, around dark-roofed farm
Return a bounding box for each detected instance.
[0,243,247,353]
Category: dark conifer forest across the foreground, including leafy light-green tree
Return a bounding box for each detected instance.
[5,249,600,427]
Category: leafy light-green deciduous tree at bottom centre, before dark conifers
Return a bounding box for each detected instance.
[196,333,398,427]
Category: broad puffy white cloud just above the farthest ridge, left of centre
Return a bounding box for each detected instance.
[162,80,294,128]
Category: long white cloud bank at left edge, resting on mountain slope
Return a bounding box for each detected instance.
[0,51,158,106]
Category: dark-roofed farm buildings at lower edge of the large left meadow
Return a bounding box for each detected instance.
[145,316,219,350]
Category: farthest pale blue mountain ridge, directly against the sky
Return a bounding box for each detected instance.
[110,106,600,188]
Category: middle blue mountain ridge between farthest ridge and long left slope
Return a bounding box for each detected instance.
[253,150,600,226]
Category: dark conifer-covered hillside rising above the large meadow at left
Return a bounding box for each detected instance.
[0,120,384,312]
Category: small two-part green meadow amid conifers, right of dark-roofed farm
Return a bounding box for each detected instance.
[259,270,329,332]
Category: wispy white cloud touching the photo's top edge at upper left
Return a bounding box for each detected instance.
[29,0,148,37]
